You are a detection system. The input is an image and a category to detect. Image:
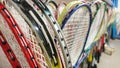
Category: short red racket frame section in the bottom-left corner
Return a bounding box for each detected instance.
[0,31,21,68]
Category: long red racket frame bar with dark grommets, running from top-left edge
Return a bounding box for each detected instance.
[0,4,38,67]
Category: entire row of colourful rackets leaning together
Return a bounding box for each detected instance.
[0,0,114,68]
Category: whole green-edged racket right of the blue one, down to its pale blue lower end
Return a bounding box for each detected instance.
[76,2,105,68]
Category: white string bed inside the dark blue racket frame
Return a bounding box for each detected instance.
[63,8,89,66]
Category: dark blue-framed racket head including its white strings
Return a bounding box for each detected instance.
[61,4,92,67]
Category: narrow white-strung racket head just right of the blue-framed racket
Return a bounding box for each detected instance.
[85,2,105,51]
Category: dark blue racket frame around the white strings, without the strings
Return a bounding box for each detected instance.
[61,4,92,68]
